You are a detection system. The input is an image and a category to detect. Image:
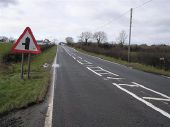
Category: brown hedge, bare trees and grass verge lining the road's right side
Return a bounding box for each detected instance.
[66,30,170,76]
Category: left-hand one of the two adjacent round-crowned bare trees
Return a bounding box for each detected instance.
[79,32,93,44]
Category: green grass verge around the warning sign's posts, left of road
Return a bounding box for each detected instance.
[0,46,56,114]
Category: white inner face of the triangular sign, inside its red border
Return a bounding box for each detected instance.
[15,31,38,51]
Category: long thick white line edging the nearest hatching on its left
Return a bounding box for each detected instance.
[112,83,170,119]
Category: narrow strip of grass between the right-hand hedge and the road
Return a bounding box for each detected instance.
[77,49,170,76]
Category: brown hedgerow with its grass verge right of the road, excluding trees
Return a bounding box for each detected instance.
[68,42,170,76]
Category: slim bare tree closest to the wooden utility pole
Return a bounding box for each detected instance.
[116,30,128,46]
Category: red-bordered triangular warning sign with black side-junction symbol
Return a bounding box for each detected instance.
[12,27,41,54]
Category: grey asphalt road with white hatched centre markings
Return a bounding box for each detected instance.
[52,46,170,127]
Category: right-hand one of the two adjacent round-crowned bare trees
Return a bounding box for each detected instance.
[93,31,107,45]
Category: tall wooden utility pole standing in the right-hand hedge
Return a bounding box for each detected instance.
[128,8,133,62]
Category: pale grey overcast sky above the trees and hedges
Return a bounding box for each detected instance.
[0,0,170,44]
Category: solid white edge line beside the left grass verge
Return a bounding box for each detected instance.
[44,46,58,127]
